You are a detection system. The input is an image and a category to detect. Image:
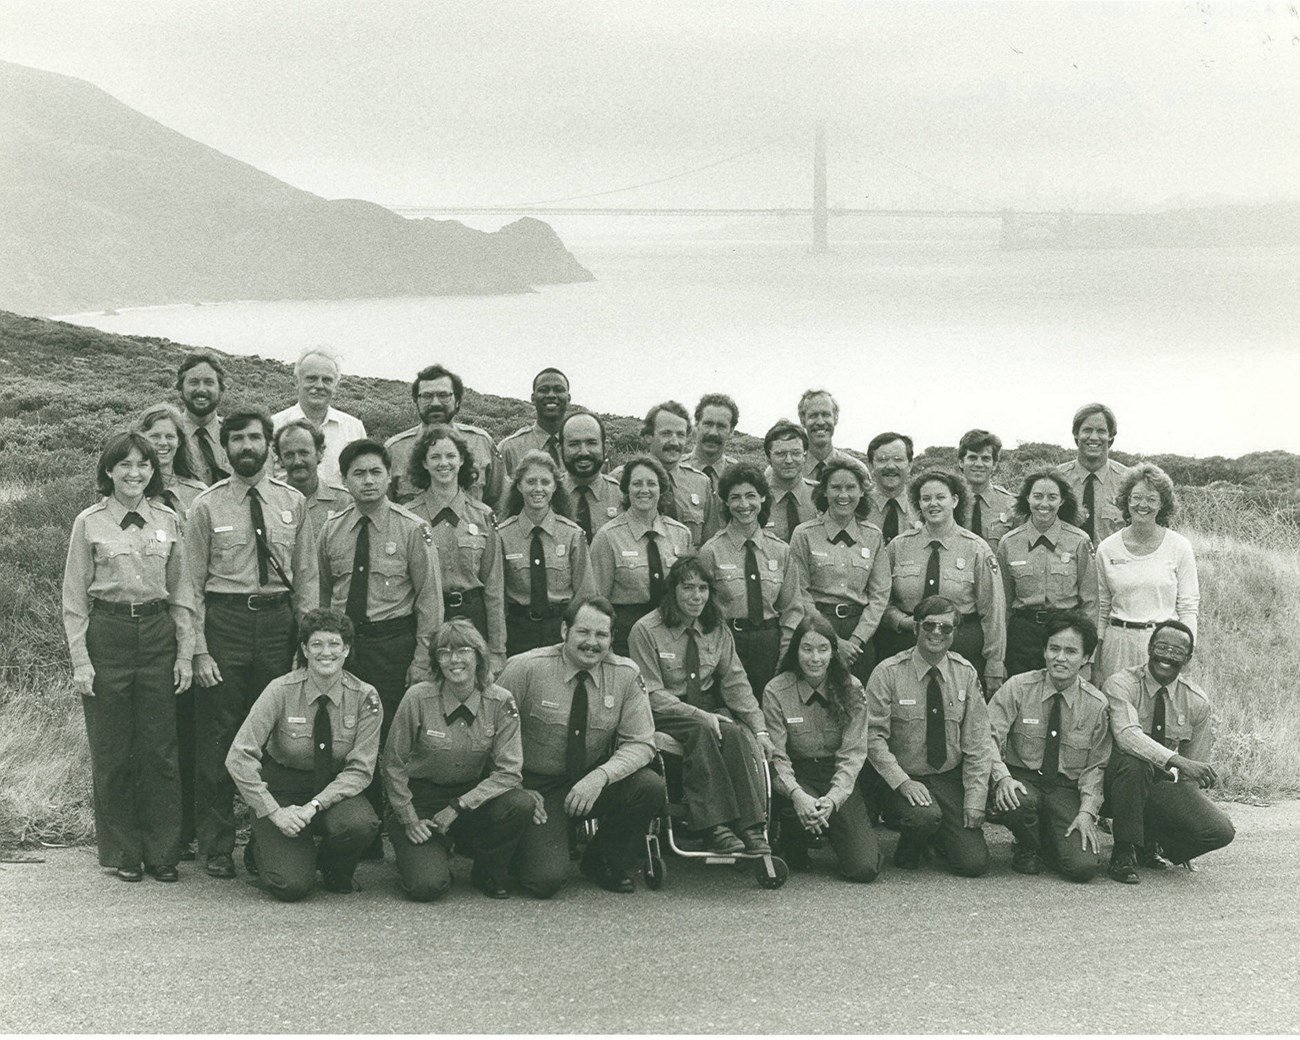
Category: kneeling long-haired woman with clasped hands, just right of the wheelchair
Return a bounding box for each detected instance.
[763,614,884,881]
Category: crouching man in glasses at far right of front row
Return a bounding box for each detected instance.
[1102,621,1236,885]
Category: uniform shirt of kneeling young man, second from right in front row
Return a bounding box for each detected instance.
[988,668,1110,816]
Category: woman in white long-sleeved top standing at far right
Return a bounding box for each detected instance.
[1092,463,1201,686]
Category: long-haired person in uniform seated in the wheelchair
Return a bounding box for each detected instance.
[628,556,772,854]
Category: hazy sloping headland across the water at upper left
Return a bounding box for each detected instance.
[0,62,592,315]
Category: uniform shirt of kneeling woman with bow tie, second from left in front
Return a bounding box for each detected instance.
[384,681,524,826]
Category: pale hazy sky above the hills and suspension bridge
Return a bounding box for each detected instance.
[0,0,1300,208]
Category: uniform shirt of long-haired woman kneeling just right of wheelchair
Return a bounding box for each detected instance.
[763,672,867,809]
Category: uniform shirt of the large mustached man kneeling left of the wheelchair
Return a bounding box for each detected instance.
[497,646,654,784]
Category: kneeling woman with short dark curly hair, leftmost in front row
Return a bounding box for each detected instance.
[226,610,384,902]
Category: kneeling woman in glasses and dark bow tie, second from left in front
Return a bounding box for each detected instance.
[384,618,533,902]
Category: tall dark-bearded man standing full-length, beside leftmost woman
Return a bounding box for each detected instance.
[185,411,320,878]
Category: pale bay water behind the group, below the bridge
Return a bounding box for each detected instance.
[64,215,1300,455]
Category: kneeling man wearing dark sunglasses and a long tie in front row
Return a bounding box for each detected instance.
[863,595,993,878]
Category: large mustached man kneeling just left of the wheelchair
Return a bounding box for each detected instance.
[497,598,663,900]
